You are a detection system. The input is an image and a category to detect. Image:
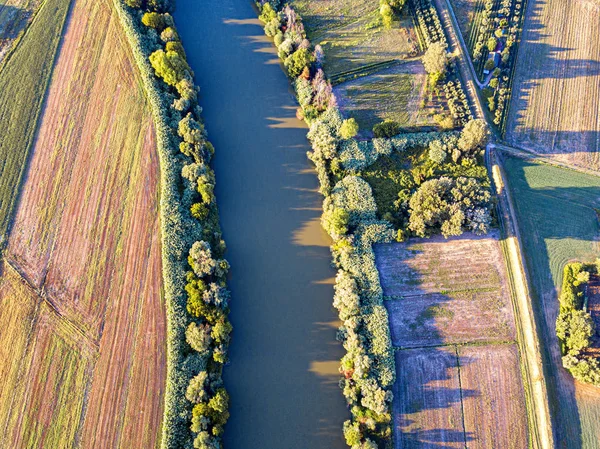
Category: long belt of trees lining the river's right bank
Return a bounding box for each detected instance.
[259,3,395,449]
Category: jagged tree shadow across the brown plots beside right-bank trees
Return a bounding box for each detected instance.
[374,243,481,449]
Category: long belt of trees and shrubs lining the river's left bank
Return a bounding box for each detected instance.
[114,0,232,449]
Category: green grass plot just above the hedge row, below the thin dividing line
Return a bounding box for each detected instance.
[334,61,441,131]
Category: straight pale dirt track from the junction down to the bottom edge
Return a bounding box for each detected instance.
[486,149,554,449]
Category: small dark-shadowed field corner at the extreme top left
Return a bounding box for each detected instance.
[0,0,42,65]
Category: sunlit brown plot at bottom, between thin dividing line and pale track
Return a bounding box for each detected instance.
[458,345,529,449]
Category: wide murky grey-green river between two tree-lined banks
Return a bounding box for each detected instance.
[175,0,349,449]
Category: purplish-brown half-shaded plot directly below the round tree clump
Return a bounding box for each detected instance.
[374,229,515,348]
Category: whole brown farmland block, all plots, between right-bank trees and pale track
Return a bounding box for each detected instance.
[374,231,529,448]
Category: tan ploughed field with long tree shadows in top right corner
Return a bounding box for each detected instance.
[506,0,600,169]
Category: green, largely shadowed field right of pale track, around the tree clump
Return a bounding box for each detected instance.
[504,153,600,448]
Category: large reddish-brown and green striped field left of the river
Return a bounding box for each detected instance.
[0,0,166,448]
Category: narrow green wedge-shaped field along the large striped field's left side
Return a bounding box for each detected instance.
[0,0,71,243]
